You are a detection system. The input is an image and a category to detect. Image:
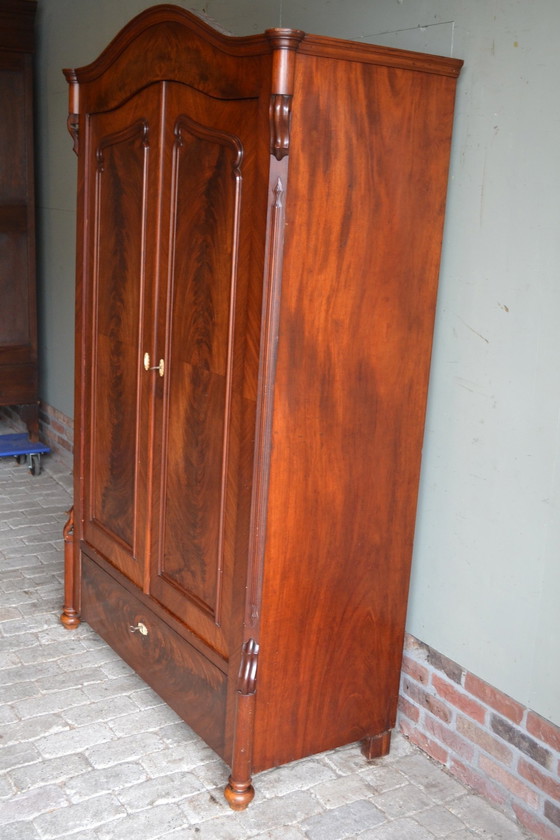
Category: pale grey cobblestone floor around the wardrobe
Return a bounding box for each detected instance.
[0,428,529,840]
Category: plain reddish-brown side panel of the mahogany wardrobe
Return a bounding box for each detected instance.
[255,56,455,770]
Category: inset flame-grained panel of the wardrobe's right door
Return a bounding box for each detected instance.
[161,117,243,624]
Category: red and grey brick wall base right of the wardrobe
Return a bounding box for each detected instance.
[399,636,560,840]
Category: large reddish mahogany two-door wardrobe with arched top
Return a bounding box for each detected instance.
[62,6,461,808]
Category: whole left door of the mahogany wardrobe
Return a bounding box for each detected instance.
[77,85,163,587]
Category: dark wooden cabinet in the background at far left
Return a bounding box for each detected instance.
[0,0,39,440]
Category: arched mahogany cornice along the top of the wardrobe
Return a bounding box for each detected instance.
[64,4,462,115]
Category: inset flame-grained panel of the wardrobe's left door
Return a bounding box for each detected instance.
[91,120,145,550]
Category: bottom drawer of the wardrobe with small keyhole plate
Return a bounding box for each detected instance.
[81,554,227,757]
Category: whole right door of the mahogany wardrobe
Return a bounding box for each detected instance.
[151,85,266,658]
